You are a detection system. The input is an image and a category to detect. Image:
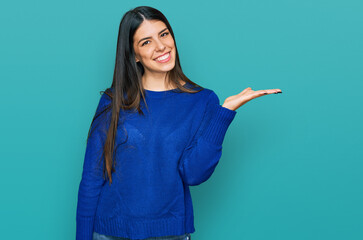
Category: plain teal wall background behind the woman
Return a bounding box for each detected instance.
[0,0,363,240]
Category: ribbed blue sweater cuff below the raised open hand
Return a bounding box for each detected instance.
[201,104,237,145]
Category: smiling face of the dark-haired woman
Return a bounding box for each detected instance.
[133,20,175,74]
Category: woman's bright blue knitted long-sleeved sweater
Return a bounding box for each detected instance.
[76,83,237,240]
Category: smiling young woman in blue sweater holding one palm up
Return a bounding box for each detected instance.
[76,6,281,240]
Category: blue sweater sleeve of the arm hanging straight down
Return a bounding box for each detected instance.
[76,90,111,240]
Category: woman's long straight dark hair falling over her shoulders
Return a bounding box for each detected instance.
[87,6,203,185]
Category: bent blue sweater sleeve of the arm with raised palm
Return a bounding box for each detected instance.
[178,91,237,186]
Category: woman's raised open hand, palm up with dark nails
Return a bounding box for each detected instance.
[222,87,282,111]
